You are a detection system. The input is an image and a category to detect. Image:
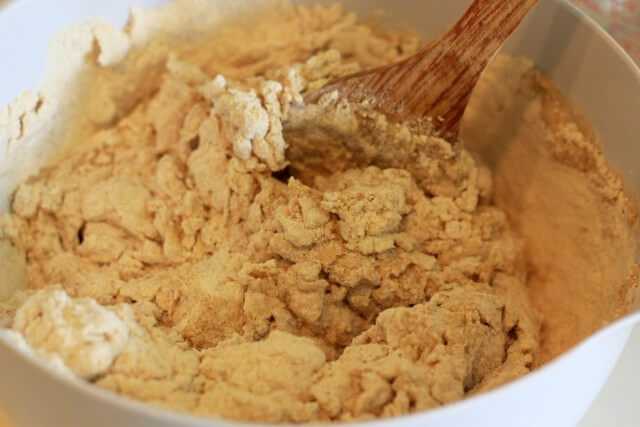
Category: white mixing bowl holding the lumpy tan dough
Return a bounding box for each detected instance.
[0,0,640,427]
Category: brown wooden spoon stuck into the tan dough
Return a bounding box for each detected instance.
[305,0,537,141]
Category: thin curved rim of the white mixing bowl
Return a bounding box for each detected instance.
[0,0,640,427]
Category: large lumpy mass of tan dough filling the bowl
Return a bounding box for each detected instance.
[0,1,636,422]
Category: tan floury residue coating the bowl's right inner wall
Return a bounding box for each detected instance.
[461,56,640,363]
